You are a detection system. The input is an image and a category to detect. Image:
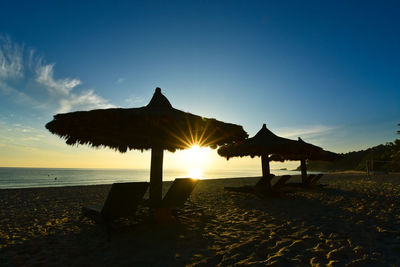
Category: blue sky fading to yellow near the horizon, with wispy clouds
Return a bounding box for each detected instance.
[0,0,400,173]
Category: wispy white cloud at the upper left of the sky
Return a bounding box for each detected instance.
[0,36,113,112]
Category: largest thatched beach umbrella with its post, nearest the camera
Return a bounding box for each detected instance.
[46,88,247,205]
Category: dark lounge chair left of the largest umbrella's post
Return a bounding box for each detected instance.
[82,182,149,229]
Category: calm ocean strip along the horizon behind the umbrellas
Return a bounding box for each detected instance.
[0,167,300,189]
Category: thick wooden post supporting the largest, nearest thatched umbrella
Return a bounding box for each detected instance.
[150,148,164,207]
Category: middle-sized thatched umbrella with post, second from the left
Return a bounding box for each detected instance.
[218,124,304,180]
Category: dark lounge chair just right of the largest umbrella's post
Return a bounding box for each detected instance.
[154,178,200,223]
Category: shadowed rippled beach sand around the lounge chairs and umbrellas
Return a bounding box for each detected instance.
[0,173,400,266]
